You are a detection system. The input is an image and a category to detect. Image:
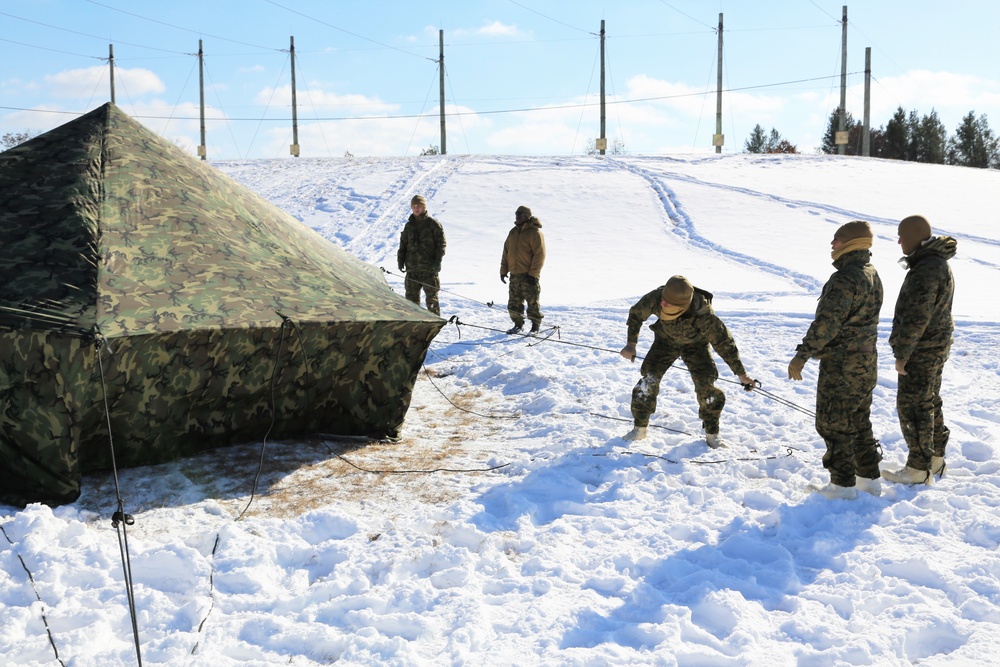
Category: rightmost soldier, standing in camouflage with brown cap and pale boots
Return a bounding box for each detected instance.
[882,215,958,484]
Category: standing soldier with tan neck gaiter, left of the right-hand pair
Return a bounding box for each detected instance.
[788,220,882,498]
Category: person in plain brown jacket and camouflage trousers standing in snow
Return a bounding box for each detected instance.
[500,206,545,334]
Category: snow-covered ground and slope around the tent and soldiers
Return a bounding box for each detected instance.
[0,155,1000,666]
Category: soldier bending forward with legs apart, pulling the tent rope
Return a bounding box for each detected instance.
[620,276,754,447]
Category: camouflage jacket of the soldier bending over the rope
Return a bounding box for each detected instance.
[628,285,746,375]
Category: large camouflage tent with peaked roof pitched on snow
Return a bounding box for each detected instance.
[0,104,444,505]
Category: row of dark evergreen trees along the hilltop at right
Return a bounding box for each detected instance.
[743,107,1000,169]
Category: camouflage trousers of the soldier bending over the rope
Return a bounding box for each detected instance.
[632,337,726,433]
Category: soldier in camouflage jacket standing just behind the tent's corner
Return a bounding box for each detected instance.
[396,195,445,315]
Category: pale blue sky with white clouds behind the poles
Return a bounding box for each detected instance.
[0,0,1000,159]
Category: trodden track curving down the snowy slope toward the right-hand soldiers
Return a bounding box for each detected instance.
[608,159,823,292]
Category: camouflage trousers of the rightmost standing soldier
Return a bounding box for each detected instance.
[896,348,951,470]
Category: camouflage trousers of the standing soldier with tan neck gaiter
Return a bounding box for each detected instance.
[816,352,882,486]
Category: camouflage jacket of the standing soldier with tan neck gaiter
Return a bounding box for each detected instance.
[795,250,882,359]
